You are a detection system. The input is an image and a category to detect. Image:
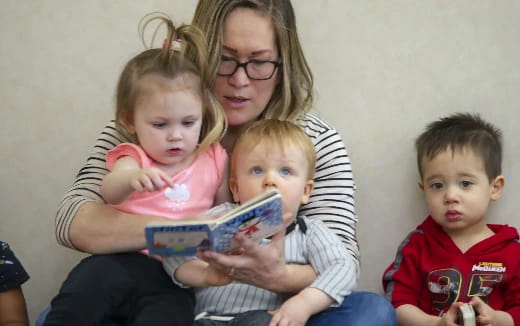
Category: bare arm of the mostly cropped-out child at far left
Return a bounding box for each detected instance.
[0,287,29,326]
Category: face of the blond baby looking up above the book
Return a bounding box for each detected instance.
[229,144,313,224]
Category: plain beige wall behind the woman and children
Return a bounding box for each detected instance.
[0,0,520,321]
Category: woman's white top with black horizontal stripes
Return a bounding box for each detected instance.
[55,114,359,273]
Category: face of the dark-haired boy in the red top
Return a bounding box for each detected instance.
[419,149,504,235]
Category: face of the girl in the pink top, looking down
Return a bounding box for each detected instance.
[126,74,202,168]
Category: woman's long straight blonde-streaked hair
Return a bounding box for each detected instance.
[192,0,313,122]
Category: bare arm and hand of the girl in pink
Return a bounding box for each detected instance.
[101,156,173,204]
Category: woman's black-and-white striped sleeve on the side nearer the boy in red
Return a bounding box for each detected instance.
[299,114,359,274]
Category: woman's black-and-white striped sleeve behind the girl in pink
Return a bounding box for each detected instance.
[55,121,129,249]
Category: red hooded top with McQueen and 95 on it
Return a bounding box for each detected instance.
[383,217,520,325]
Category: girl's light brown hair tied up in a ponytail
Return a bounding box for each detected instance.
[115,13,227,151]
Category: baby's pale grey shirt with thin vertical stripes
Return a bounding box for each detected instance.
[163,217,357,315]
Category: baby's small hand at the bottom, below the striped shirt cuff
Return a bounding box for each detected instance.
[269,295,311,326]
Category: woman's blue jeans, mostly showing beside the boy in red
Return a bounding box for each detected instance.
[36,291,397,326]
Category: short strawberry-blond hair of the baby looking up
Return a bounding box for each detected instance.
[230,119,316,180]
